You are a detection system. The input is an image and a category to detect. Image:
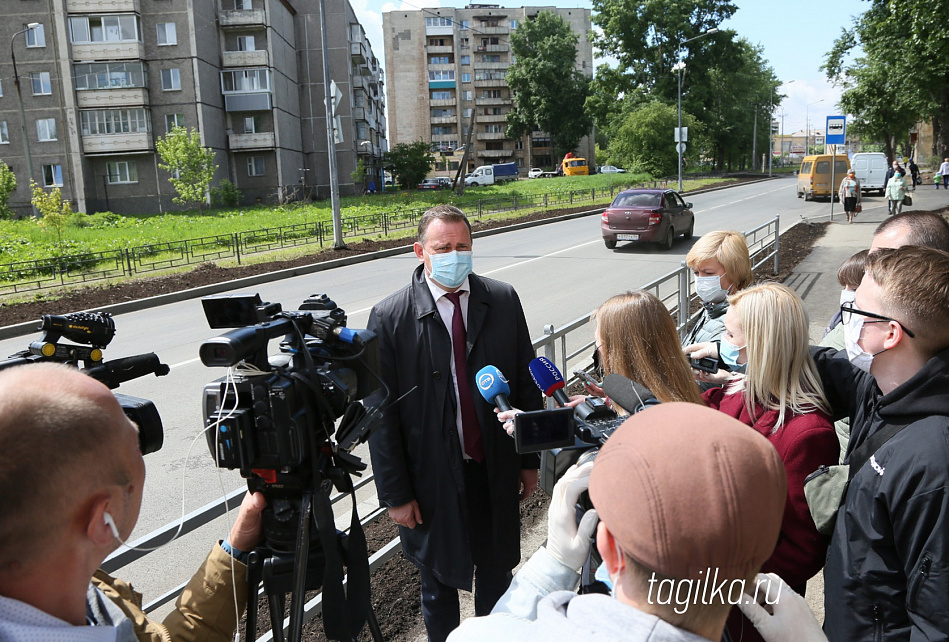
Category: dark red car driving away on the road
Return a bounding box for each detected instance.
[600,189,695,250]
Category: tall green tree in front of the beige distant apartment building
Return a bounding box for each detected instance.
[506,11,593,158]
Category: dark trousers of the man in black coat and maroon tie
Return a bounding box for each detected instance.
[421,462,513,642]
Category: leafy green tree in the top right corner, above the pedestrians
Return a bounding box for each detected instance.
[822,0,949,158]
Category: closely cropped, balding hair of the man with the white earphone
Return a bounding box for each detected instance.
[0,363,131,569]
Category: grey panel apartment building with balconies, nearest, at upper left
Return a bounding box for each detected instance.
[0,0,387,213]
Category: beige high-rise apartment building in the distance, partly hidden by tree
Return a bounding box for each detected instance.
[382,4,594,171]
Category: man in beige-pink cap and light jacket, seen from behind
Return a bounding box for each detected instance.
[449,403,822,642]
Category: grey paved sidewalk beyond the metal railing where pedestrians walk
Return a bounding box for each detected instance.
[785,185,949,622]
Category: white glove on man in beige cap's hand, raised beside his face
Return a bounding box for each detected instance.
[546,462,596,571]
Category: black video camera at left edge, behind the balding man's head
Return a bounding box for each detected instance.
[0,312,169,455]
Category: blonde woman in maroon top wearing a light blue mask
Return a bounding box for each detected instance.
[691,283,838,640]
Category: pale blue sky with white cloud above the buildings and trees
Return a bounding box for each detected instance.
[350,0,870,133]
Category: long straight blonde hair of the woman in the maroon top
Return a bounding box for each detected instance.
[728,283,830,430]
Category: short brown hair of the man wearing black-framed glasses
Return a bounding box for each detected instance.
[866,245,949,357]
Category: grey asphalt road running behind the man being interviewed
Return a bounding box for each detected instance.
[0,171,828,601]
